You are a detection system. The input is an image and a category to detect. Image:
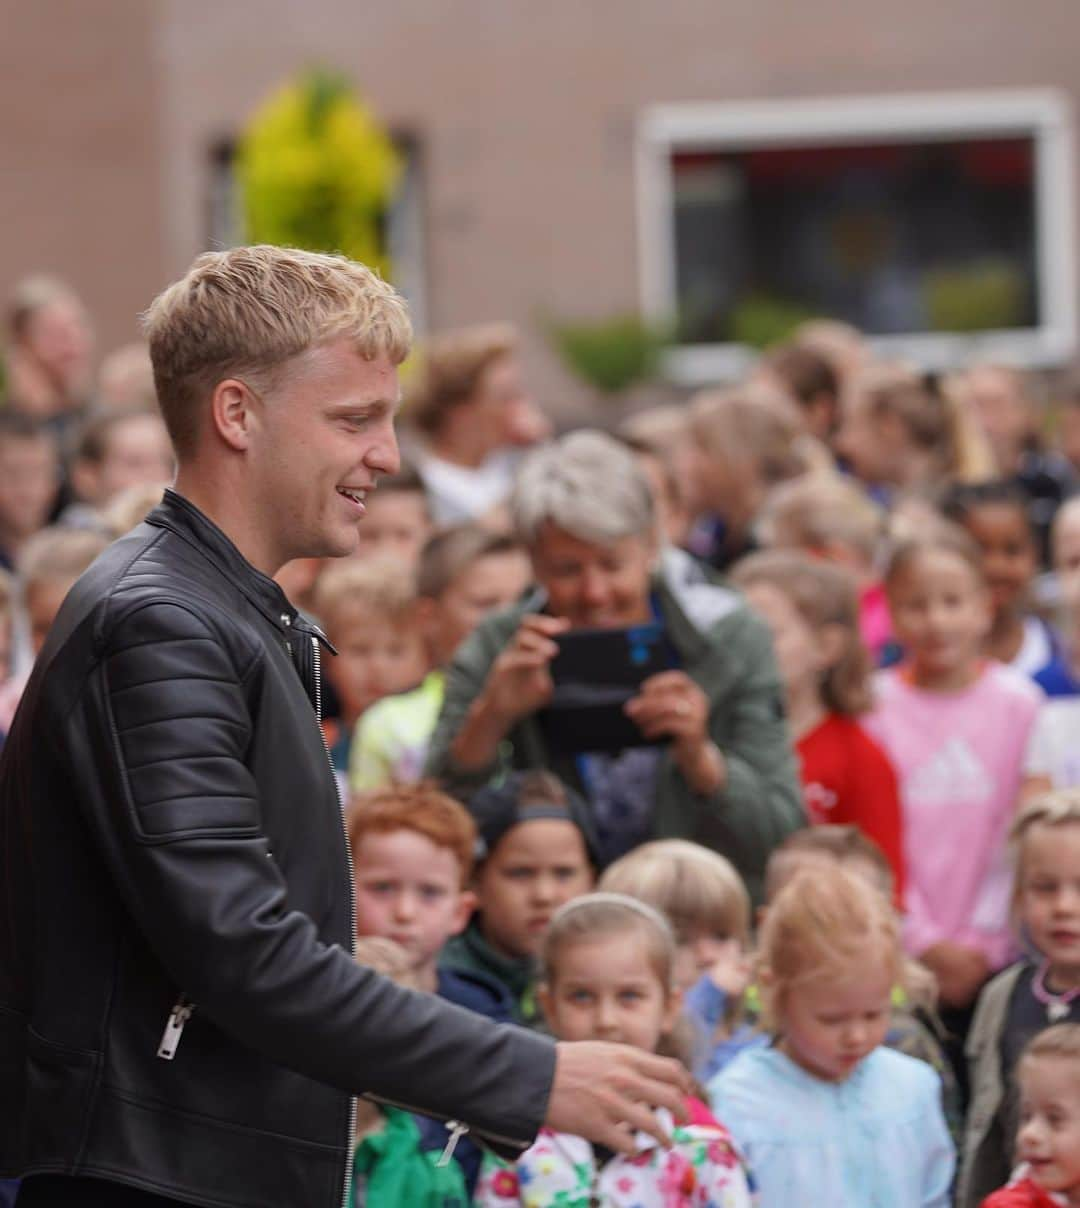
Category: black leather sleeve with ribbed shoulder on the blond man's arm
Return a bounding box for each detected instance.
[64,602,554,1149]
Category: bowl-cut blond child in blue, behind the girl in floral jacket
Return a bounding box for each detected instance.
[598,838,766,1082]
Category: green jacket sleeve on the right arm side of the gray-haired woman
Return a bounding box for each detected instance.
[667,610,806,900]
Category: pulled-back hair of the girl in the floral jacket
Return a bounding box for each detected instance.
[540,893,675,993]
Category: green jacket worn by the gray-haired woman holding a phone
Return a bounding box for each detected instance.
[428,550,806,905]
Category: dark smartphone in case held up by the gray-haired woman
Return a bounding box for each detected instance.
[538,621,679,755]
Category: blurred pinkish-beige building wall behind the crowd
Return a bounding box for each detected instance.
[0,0,1080,415]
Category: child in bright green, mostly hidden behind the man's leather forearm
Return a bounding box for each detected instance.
[349,939,469,1208]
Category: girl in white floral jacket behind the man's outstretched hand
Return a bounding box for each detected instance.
[475,894,753,1208]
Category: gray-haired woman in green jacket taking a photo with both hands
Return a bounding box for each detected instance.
[428,431,803,900]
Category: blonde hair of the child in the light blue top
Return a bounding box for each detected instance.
[759,865,905,1033]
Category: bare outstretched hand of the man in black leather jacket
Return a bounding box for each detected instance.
[544,1040,691,1155]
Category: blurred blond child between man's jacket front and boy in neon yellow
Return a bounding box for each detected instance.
[314,553,429,784]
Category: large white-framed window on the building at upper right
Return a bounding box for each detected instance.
[638,92,1075,382]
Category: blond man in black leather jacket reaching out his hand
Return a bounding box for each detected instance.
[0,248,681,1208]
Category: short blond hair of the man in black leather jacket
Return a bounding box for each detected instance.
[143,244,412,457]
